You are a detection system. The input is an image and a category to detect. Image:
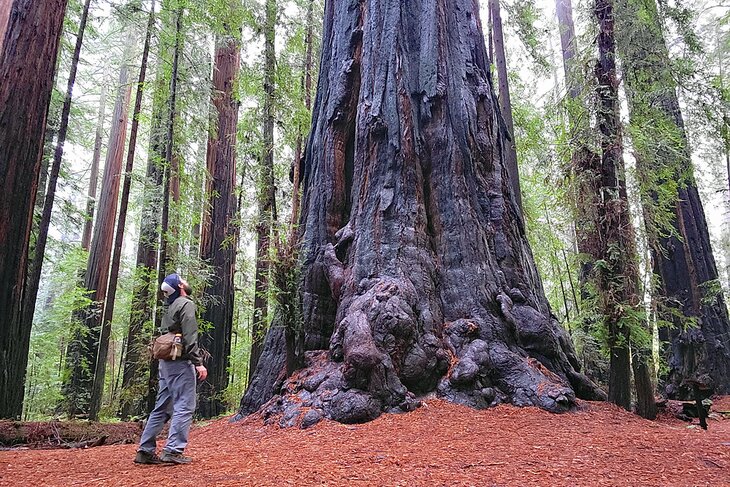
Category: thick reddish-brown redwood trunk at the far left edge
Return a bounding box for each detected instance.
[0,0,67,418]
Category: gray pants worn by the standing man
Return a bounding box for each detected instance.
[139,360,196,453]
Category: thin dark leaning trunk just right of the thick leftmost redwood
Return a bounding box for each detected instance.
[22,0,91,394]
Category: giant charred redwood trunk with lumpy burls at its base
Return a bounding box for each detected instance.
[241,0,604,426]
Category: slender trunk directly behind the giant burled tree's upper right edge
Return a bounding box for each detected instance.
[489,0,522,215]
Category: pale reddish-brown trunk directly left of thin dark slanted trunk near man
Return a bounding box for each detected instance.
[64,54,132,417]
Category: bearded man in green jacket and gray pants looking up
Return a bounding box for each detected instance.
[134,274,208,464]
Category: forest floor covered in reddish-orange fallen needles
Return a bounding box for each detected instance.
[0,397,730,487]
